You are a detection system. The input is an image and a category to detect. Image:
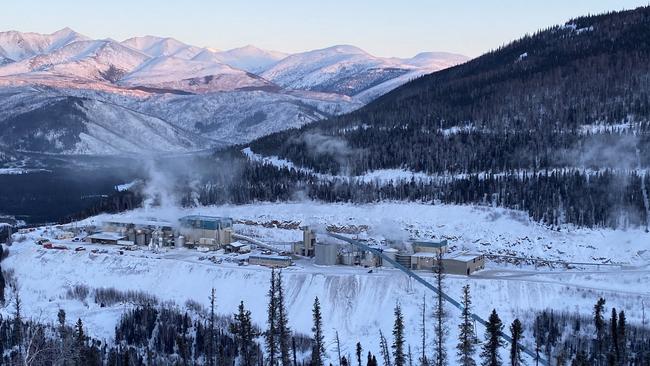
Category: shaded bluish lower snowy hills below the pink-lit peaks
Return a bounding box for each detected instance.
[0,87,360,155]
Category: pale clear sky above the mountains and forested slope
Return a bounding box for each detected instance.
[0,0,648,57]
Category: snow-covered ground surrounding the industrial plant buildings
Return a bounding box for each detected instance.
[3,202,650,364]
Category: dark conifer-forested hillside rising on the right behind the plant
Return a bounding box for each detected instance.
[246,7,650,226]
